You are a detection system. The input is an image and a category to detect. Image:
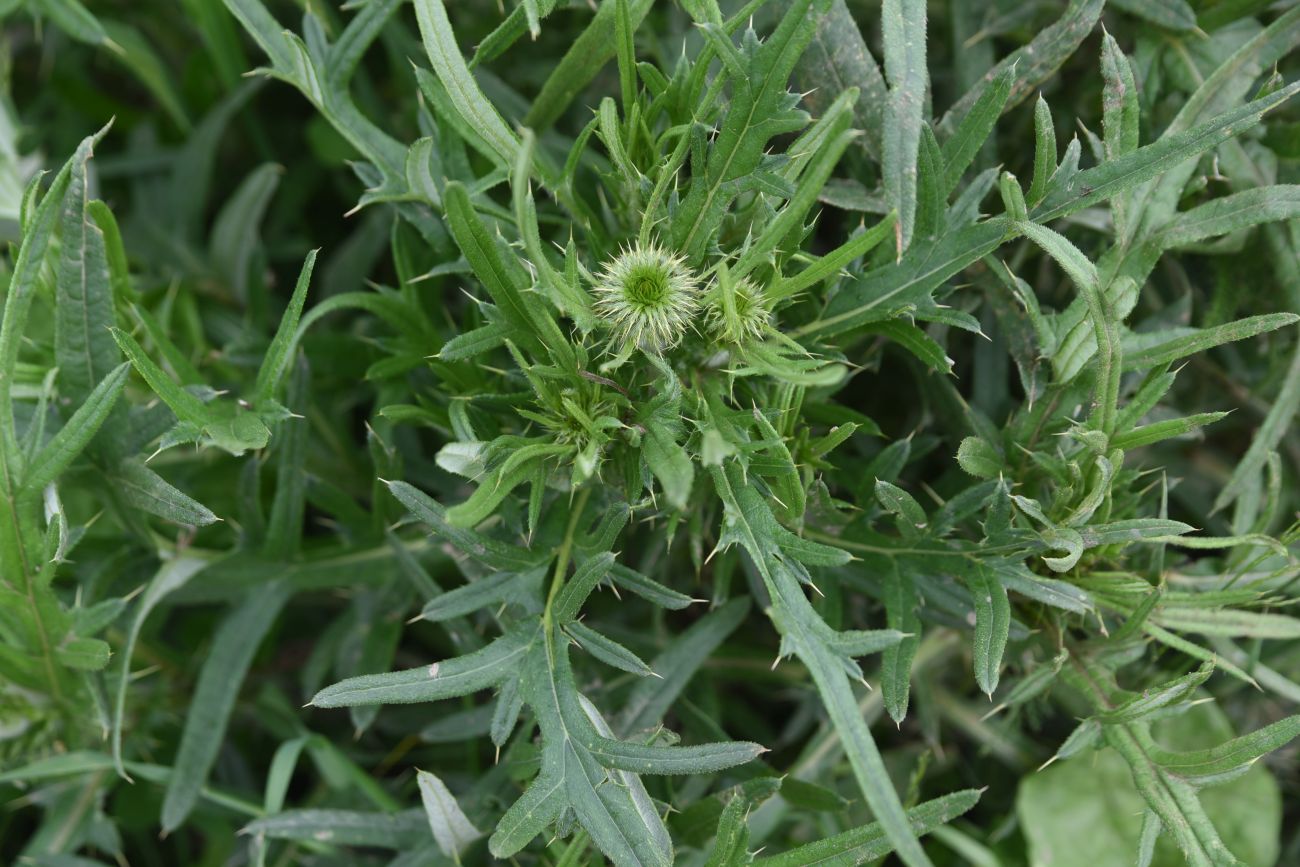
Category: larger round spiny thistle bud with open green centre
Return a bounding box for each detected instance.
[595,243,699,352]
